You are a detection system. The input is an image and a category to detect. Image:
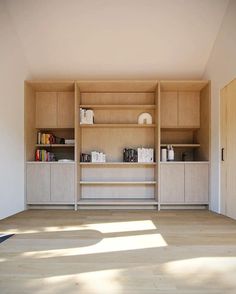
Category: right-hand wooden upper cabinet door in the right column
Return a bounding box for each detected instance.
[178,92,200,128]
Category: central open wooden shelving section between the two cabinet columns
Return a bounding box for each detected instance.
[77,81,159,208]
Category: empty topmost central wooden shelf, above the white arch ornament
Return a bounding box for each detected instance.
[80,104,156,110]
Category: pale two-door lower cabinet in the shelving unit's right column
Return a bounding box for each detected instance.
[160,162,209,204]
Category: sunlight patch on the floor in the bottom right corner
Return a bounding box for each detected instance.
[164,257,236,287]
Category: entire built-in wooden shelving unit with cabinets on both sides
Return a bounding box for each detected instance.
[25,80,210,209]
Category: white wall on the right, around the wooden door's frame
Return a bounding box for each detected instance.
[204,0,236,212]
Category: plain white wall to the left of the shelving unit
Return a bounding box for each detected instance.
[0,1,28,219]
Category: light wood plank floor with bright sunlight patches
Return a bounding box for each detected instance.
[0,210,236,294]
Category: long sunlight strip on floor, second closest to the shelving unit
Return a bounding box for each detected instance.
[22,234,167,258]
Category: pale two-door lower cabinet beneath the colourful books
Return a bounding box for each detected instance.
[26,162,75,204]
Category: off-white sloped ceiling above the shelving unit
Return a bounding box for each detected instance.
[5,0,228,79]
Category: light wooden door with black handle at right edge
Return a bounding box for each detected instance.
[220,79,236,219]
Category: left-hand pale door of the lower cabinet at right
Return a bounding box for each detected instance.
[160,163,184,203]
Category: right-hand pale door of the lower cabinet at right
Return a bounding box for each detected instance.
[185,162,209,203]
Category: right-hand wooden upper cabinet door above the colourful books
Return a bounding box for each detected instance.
[57,92,75,128]
